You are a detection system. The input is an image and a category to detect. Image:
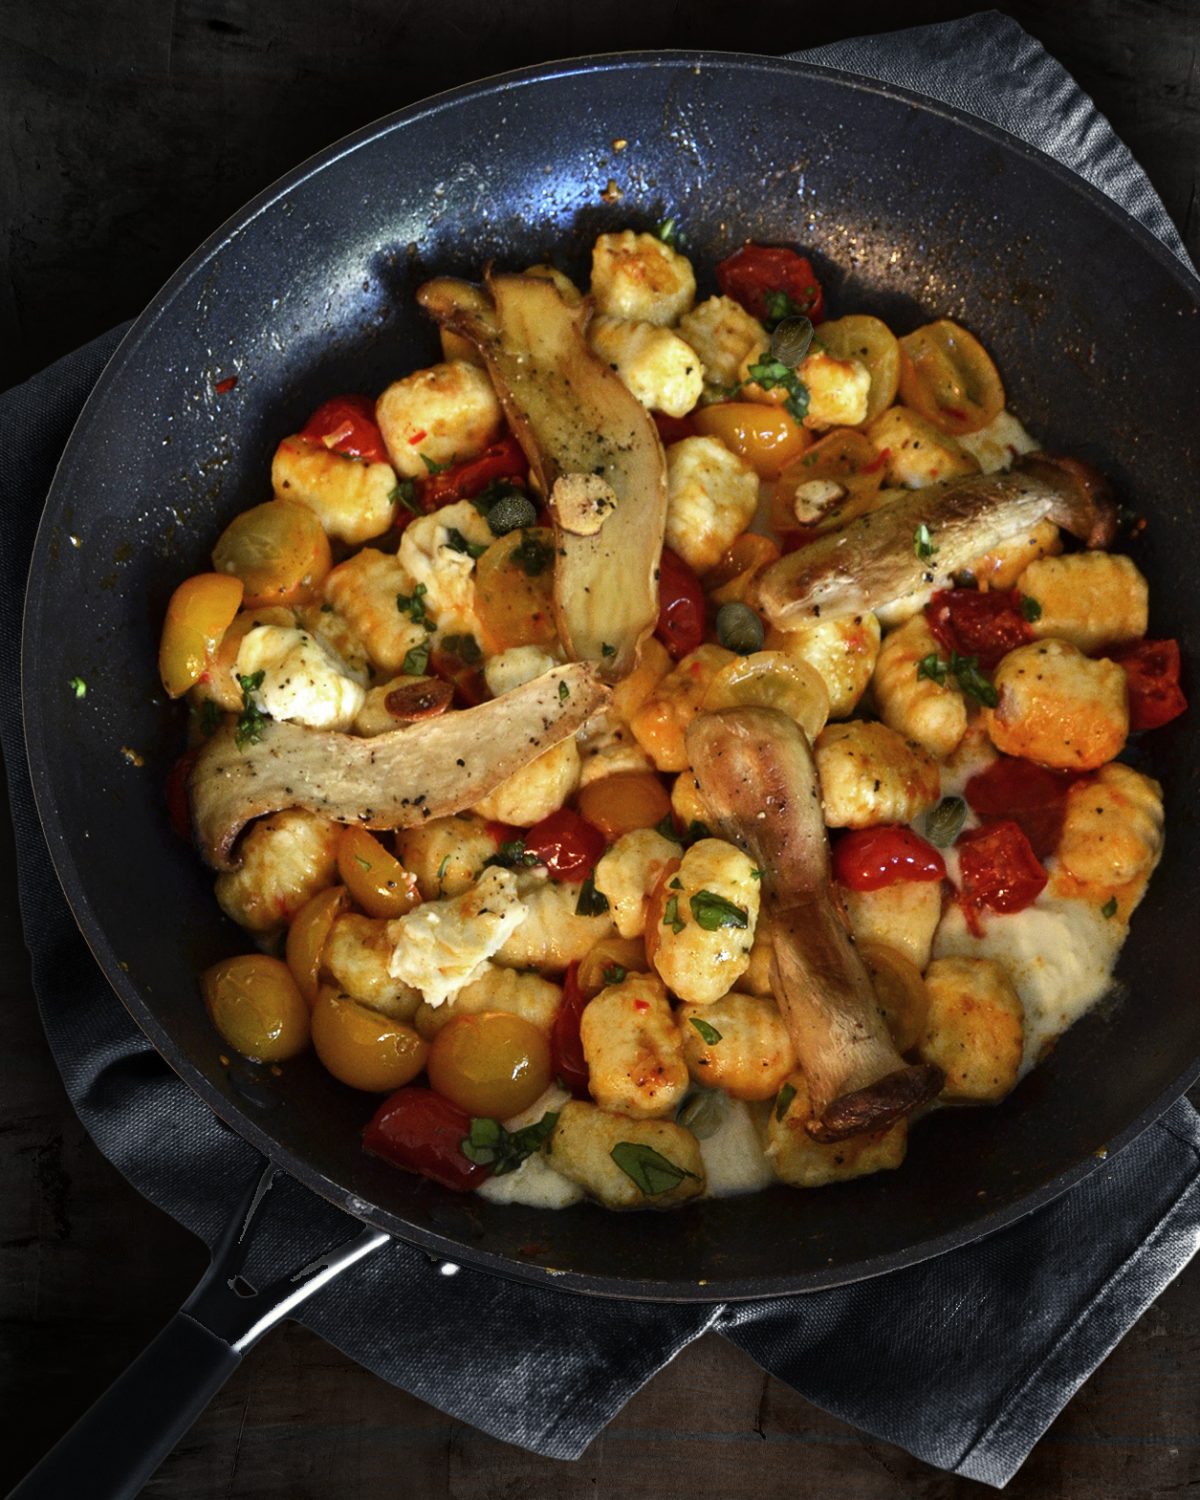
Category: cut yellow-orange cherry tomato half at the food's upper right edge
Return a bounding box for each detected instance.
[900,318,1004,438]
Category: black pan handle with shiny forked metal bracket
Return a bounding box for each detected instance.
[9,1167,389,1500]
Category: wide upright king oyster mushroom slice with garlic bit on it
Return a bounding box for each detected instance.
[417,273,666,683]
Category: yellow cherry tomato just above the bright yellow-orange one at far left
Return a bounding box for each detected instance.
[213,500,333,609]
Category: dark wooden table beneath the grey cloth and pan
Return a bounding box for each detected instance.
[0,0,1200,1500]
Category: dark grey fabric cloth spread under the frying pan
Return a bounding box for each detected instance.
[0,14,1200,1485]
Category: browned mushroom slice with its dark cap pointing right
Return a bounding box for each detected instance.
[758,453,1116,627]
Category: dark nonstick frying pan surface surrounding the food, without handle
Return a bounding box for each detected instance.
[14,41,1200,1494]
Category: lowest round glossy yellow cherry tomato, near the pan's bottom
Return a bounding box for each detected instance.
[426,1011,552,1121]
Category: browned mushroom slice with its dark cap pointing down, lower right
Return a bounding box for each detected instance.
[687,708,942,1142]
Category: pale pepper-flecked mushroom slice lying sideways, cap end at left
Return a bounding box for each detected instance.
[195,663,609,870]
